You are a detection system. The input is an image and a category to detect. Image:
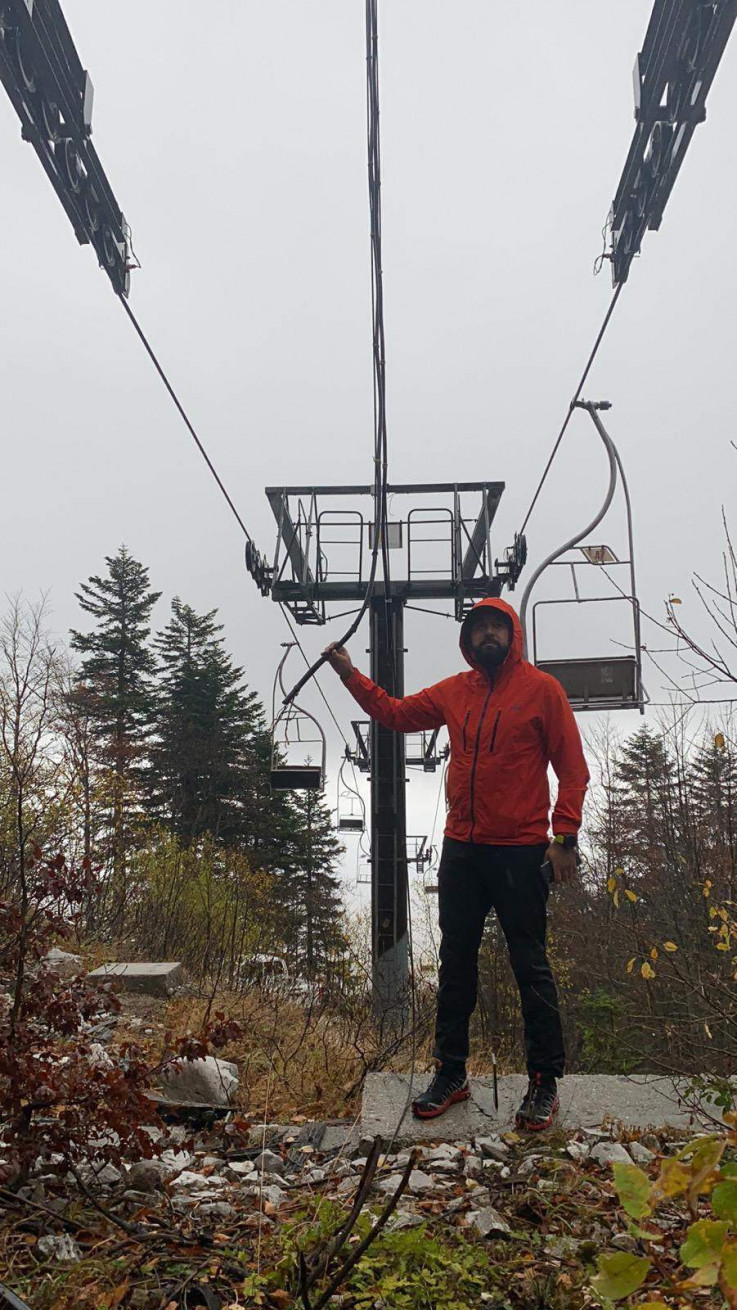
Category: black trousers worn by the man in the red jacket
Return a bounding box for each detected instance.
[435,837,566,1078]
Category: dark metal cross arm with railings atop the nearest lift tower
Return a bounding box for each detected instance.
[266,482,524,625]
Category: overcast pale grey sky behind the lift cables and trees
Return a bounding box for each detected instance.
[0,0,737,906]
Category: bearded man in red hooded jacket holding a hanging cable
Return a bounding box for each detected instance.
[326,597,589,1131]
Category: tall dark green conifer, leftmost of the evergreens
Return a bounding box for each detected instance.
[71,546,161,926]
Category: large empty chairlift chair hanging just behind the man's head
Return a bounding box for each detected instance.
[520,401,647,714]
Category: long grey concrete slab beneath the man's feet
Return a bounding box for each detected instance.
[361,1073,720,1146]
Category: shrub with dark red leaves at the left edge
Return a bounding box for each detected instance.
[0,850,238,1187]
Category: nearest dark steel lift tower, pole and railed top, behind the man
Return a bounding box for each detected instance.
[266,482,525,1022]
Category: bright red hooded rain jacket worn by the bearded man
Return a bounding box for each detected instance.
[344,597,589,846]
